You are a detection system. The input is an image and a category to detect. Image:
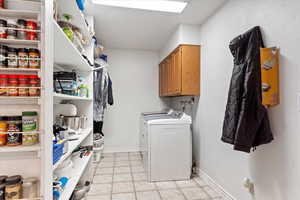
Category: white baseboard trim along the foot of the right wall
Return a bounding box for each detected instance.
[197,168,237,200]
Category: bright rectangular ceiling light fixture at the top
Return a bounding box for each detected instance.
[92,0,187,13]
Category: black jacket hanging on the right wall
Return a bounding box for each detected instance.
[222,27,273,153]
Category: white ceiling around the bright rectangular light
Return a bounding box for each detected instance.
[85,0,226,50]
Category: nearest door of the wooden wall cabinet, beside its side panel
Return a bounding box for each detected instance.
[172,48,182,95]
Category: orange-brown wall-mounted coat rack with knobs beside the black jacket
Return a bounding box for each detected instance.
[260,47,280,107]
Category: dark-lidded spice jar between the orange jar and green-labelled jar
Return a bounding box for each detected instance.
[7,116,22,146]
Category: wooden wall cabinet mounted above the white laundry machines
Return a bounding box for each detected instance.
[159,45,200,97]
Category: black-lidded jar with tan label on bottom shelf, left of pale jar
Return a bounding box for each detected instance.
[5,175,22,200]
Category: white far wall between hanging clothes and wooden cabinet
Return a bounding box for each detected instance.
[103,49,168,152]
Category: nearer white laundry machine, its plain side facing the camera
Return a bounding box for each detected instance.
[142,112,192,182]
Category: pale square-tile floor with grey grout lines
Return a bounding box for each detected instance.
[87,152,225,200]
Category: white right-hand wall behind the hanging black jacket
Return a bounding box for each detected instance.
[169,0,300,200]
